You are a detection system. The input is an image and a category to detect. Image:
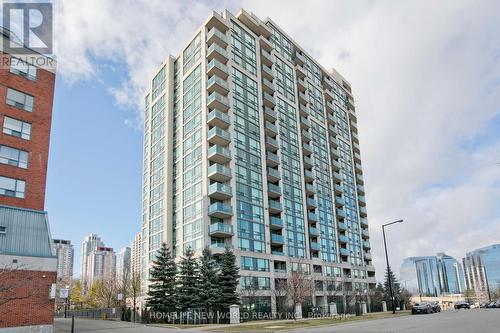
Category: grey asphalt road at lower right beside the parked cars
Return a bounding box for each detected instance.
[301,309,500,333]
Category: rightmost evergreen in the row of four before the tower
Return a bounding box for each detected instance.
[218,248,240,311]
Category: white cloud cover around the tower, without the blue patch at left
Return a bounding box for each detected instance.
[52,0,500,277]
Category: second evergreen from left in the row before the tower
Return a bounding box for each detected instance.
[177,248,200,311]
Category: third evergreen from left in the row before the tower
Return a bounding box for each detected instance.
[199,247,220,312]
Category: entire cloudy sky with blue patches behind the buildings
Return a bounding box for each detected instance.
[43,0,500,278]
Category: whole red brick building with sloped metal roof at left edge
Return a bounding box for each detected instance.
[0,29,57,332]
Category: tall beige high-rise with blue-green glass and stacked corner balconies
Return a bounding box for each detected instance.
[141,10,375,305]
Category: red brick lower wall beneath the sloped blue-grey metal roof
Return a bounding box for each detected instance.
[0,270,57,328]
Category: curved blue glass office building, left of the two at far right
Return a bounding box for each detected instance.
[400,253,465,297]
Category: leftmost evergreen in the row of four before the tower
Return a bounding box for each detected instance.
[147,243,177,313]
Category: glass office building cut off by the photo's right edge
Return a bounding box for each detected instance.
[463,244,500,298]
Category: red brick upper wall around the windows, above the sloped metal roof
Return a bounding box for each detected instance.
[0,54,55,210]
